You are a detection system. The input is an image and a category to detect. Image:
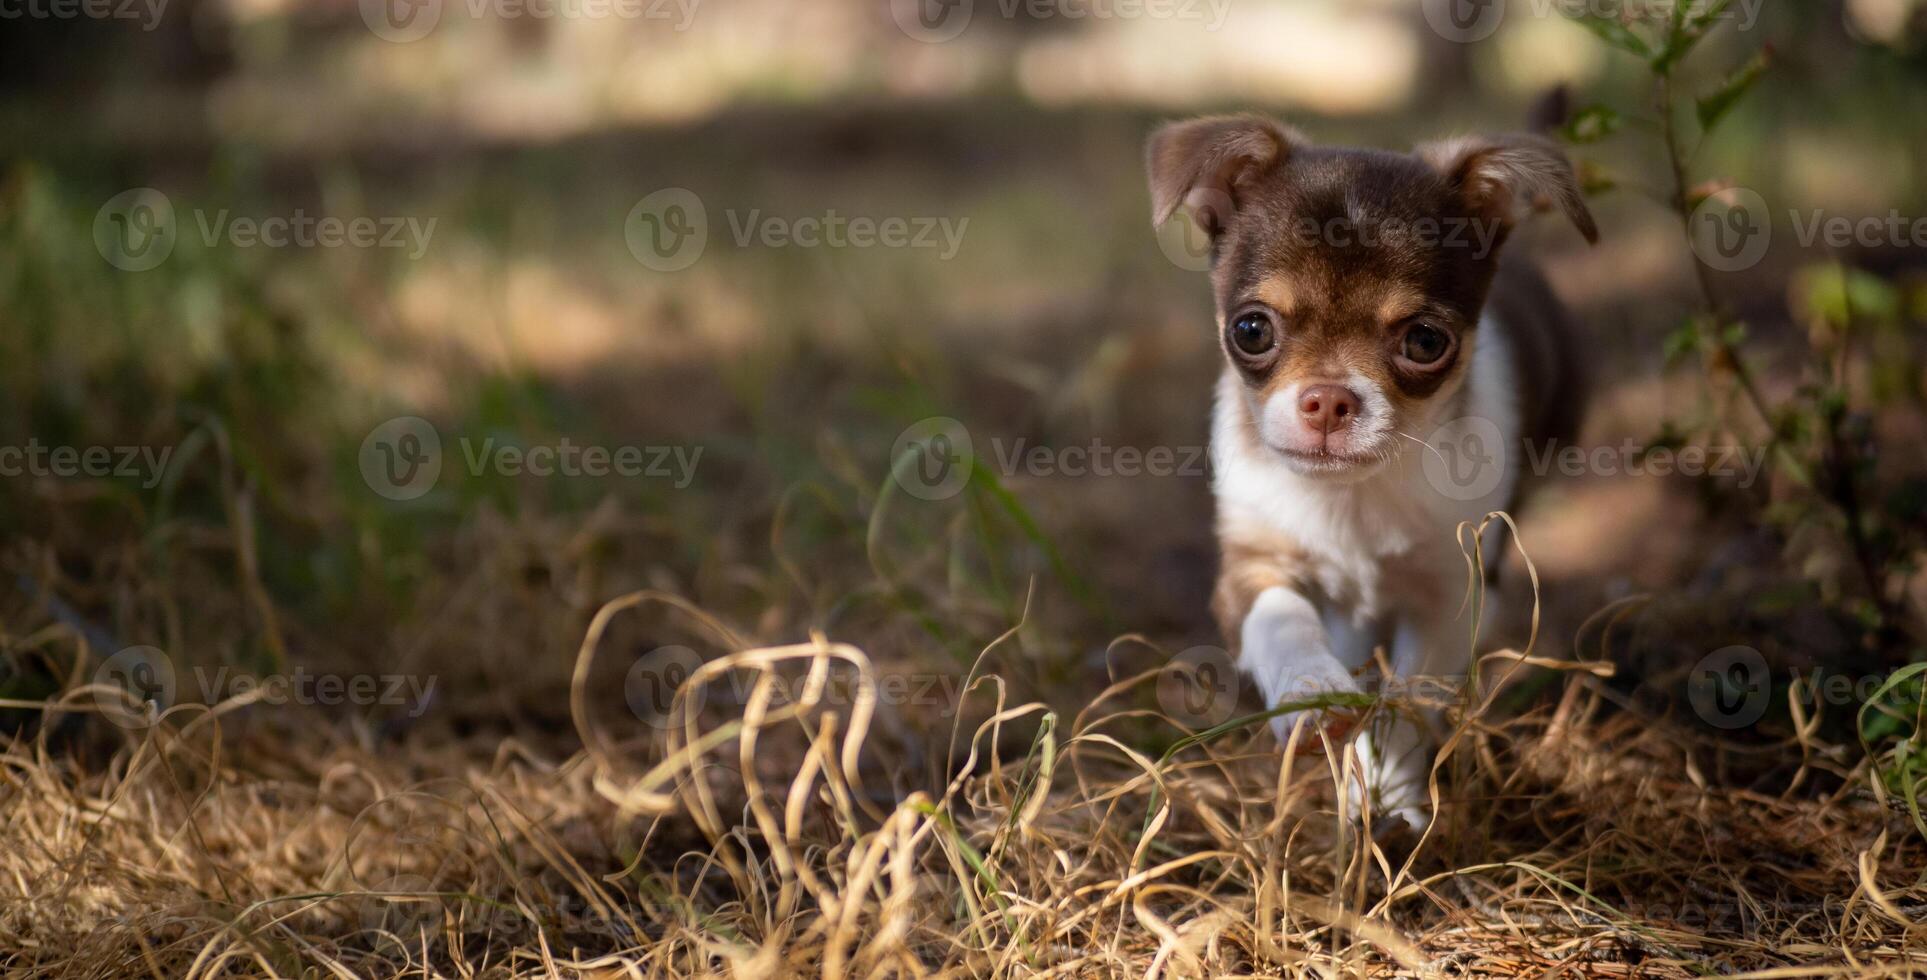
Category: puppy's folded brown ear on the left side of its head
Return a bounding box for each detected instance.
[1145,116,1299,237]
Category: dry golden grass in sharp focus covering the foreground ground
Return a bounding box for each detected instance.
[0,550,1927,976]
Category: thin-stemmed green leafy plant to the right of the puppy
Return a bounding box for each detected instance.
[1563,0,1923,649]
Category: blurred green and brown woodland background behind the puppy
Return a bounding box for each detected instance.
[11,0,1927,784]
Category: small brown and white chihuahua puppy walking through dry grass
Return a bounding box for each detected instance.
[1147,116,1597,826]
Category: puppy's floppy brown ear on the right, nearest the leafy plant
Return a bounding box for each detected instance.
[1412,135,1599,243]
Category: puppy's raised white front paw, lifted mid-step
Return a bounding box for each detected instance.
[1237,585,1359,743]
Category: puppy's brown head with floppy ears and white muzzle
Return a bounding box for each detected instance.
[1147,116,1597,477]
